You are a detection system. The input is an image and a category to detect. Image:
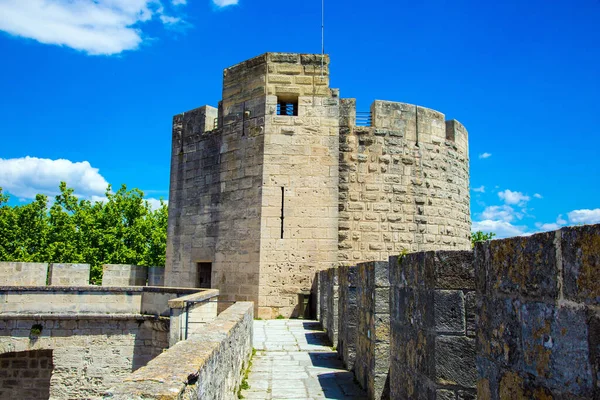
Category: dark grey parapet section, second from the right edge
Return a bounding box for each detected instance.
[390,251,477,399]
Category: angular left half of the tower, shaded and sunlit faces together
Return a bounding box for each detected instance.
[165,53,339,318]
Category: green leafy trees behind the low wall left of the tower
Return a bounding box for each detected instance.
[0,182,168,283]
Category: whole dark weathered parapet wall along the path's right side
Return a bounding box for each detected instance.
[319,225,600,400]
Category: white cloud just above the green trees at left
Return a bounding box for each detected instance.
[0,157,108,199]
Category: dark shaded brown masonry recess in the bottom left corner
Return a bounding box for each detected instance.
[0,350,53,400]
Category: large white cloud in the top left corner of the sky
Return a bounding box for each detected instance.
[0,0,185,55]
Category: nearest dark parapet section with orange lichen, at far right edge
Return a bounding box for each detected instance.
[475,225,600,399]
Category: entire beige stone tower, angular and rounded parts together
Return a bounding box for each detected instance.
[165,53,470,318]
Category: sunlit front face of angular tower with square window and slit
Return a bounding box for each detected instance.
[258,53,339,318]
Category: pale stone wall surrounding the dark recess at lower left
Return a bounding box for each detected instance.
[0,313,169,399]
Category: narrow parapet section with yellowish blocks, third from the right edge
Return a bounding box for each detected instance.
[354,261,390,399]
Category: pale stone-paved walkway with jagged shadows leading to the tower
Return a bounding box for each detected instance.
[241,319,366,400]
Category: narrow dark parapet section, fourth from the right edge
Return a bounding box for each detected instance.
[337,266,358,371]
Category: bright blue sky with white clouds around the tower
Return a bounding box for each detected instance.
[0,0,600,237]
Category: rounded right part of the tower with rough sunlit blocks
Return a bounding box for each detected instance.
[339,101,470,265]
